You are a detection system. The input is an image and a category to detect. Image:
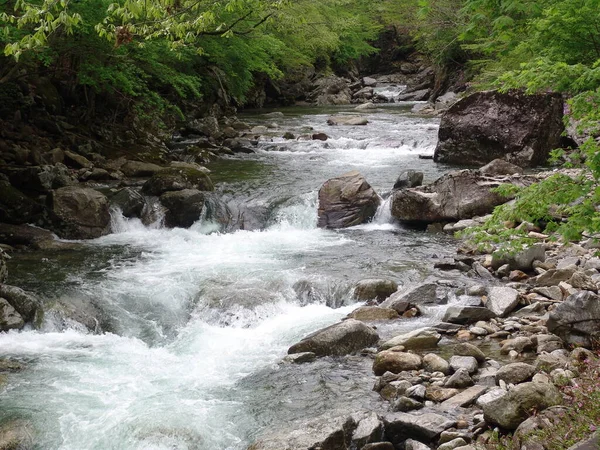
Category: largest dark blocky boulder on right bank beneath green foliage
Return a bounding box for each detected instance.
[434,91,564,167]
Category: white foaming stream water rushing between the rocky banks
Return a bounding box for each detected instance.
[0,99,464,450]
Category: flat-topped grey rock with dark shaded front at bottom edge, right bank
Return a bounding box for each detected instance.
[383,412,455,448]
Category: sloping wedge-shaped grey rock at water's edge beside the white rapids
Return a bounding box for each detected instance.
[288,319,385,356]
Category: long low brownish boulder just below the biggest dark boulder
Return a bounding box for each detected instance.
[391,170,532,224]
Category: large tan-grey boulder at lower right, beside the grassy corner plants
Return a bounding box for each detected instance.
[483,382,562,430]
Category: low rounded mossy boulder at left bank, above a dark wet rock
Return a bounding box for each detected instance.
[142,167,214,196]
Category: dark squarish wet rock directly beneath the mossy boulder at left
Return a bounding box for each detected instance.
[160,189,205,228]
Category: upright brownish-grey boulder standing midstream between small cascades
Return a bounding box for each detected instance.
[318,171,381,228]
